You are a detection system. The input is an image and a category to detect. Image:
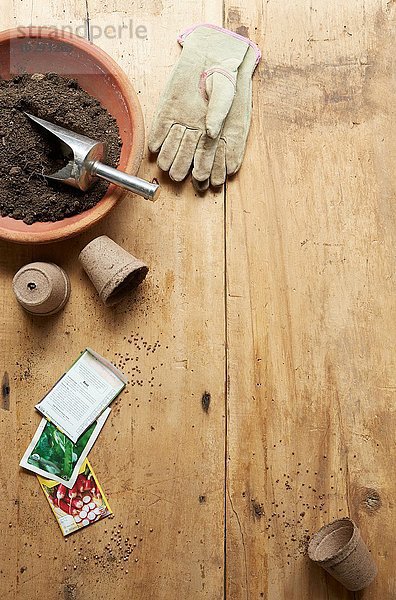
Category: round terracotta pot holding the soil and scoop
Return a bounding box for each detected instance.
[0,27,144,244]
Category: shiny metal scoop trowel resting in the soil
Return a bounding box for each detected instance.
[25,113,160,202]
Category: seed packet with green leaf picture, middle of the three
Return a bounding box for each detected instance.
[19,408,110,488]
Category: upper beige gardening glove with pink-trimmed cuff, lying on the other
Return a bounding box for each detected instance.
[149,25,254,181]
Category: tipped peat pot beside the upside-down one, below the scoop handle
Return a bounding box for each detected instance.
[79,235,148,306]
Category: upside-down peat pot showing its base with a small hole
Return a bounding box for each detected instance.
[12,262,70,316]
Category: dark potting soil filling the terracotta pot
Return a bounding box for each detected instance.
[0,73,122,225]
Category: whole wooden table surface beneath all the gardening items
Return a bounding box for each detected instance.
[0,0,396,600]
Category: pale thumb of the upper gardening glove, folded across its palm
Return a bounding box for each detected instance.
[206,72,235,139]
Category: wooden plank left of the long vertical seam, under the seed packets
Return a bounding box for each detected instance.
[0,0,225,600]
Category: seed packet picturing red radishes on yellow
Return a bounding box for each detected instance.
[37,459,113,536]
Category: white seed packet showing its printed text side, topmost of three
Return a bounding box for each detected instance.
[36,348,127,443]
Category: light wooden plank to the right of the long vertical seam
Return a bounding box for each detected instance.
[225,0,396,600]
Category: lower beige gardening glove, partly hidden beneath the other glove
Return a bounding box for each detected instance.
[192,45,261,192]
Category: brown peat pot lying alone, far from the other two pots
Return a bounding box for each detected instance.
[308,518,377,592]
